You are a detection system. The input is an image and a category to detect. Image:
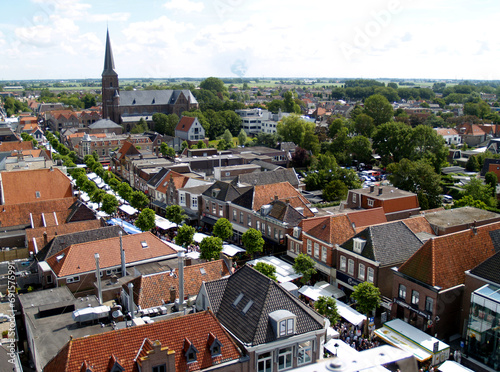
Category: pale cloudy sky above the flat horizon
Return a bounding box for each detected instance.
[0,0,500,80]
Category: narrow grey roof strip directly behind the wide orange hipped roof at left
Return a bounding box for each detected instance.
[36,226,126,261]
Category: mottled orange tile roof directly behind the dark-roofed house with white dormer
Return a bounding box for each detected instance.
[128,260,230,309]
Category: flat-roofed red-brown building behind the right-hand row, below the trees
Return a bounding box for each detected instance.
[342,186,420,221]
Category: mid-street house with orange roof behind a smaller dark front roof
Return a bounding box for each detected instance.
[228,182,314,245]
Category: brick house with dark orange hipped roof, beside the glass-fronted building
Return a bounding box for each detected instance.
[391,222,500,338]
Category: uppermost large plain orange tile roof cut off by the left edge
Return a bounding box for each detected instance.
[1,168,73,205]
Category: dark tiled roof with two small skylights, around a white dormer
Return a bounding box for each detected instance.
[210,266,324,346]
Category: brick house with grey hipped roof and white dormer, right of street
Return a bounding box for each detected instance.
[336,221,423,304]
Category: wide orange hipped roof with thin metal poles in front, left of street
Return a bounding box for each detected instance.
[47,232,177,277]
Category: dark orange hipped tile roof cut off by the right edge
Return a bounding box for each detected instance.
[399,222,500,289]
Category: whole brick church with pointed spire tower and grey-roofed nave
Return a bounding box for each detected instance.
[102,31,198,132]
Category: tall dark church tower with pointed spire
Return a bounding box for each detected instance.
[101,30,120,124]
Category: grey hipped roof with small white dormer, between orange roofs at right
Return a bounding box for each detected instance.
[341,221,423,266]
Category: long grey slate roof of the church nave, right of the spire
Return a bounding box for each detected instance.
[120,89,198,106]
